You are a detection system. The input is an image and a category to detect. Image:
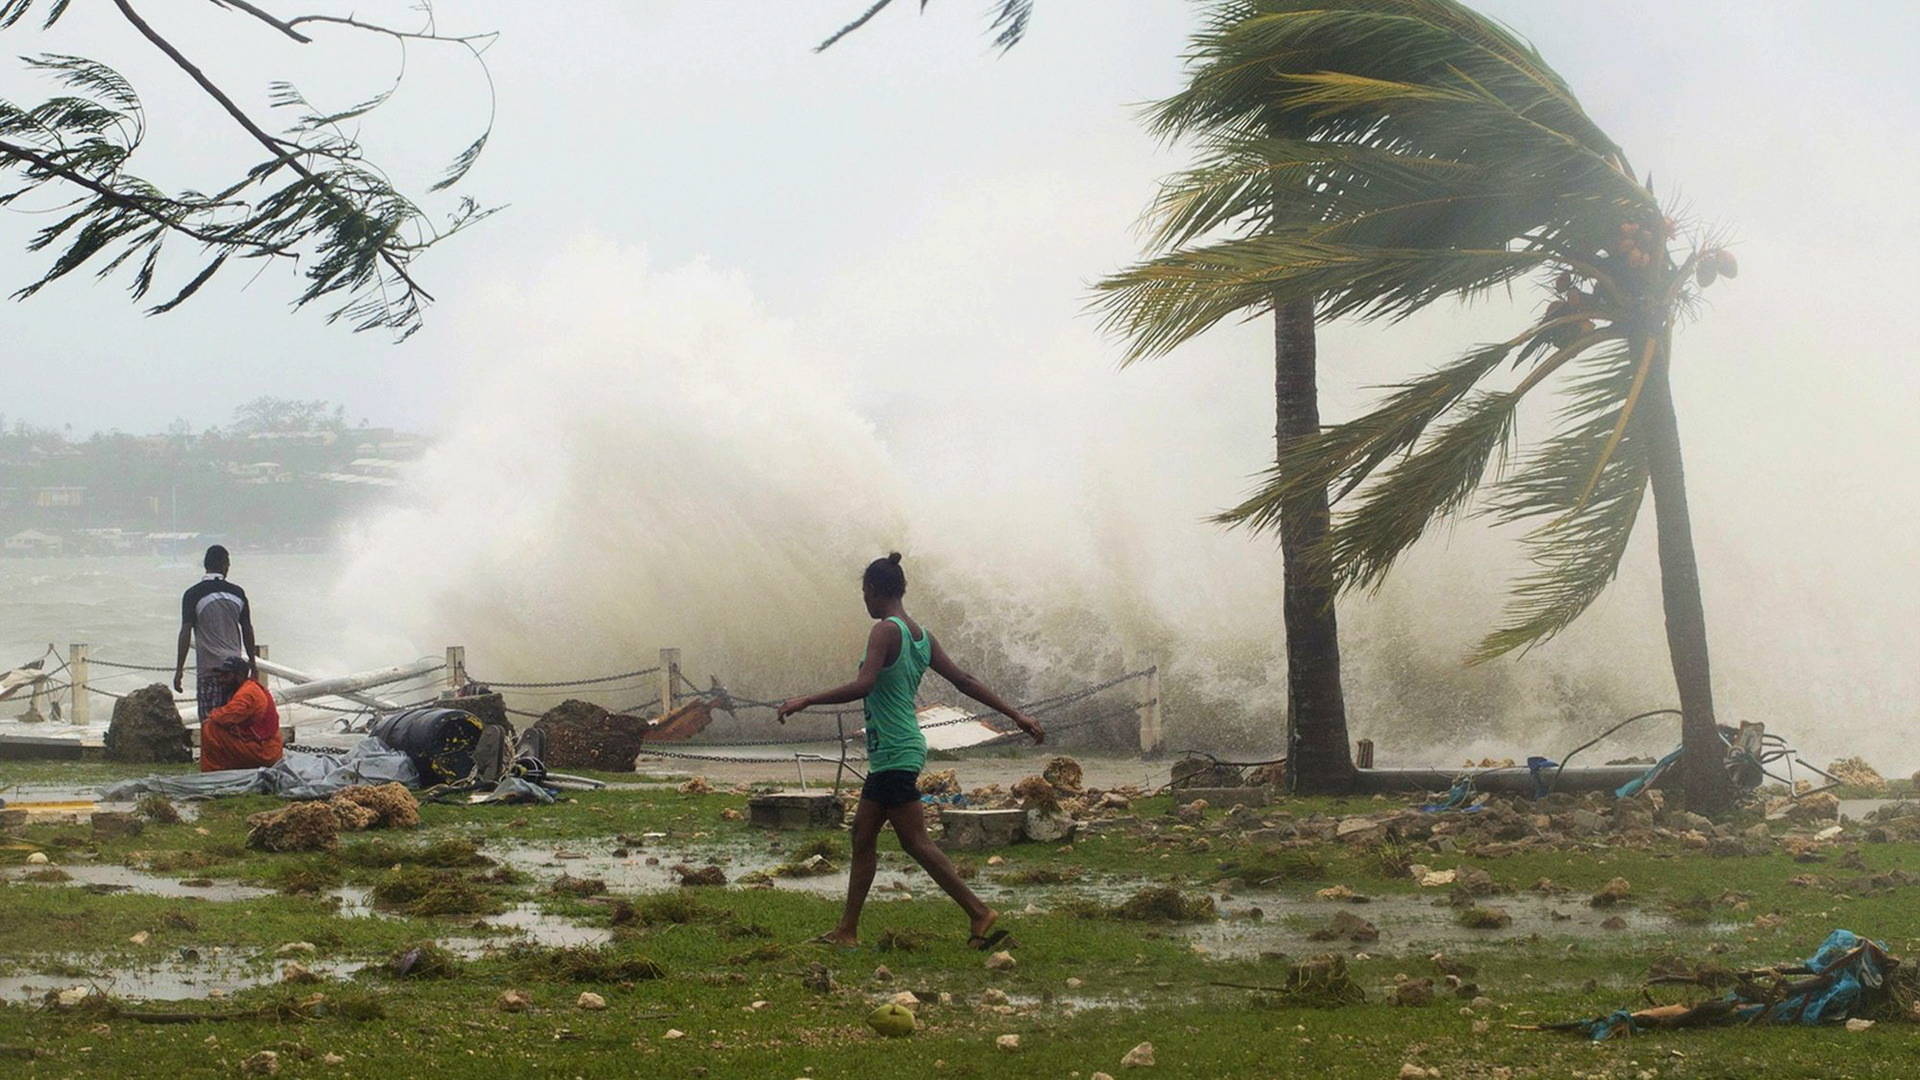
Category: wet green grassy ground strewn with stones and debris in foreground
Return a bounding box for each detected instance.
[0,767,1920,1078]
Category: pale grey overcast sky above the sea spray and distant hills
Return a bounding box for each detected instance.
[0,0,1920,440]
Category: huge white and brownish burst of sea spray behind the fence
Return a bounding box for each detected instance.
[322,244,1735,763]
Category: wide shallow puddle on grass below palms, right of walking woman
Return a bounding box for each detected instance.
[1181,894,1716,959]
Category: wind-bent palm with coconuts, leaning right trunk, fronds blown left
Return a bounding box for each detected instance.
[1102,0,1738,807]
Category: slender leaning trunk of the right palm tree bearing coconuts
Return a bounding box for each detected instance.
[1644,340,1734,813]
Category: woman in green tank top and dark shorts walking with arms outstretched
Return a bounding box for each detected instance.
[780,552,1046,949]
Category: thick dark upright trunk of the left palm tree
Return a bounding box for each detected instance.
[1273,300,1354,794]
